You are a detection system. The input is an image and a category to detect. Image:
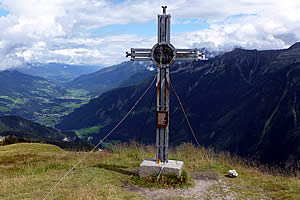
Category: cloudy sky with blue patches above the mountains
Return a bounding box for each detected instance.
[0,0,300,70]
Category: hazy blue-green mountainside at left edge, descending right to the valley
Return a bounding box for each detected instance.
[0,71,65,118]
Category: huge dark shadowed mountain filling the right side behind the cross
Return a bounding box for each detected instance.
[57,43,300,163]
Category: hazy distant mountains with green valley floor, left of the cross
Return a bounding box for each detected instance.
[0,62,154,126]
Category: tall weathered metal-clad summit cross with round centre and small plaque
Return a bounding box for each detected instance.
[126,6,202,162]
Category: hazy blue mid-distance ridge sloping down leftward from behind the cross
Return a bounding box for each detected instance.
[65,62,156,94]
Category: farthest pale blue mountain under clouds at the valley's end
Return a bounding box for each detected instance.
[16,63,102,84]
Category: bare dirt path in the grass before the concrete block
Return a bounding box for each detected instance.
[126,173,233,200]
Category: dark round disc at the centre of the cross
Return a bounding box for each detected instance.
[152,43,176,67]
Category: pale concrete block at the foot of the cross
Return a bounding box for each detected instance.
[139,159,183,177]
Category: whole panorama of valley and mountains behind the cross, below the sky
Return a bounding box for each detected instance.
[0,43,300,167]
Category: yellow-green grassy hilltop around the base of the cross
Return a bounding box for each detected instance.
[0,143,300,200]
